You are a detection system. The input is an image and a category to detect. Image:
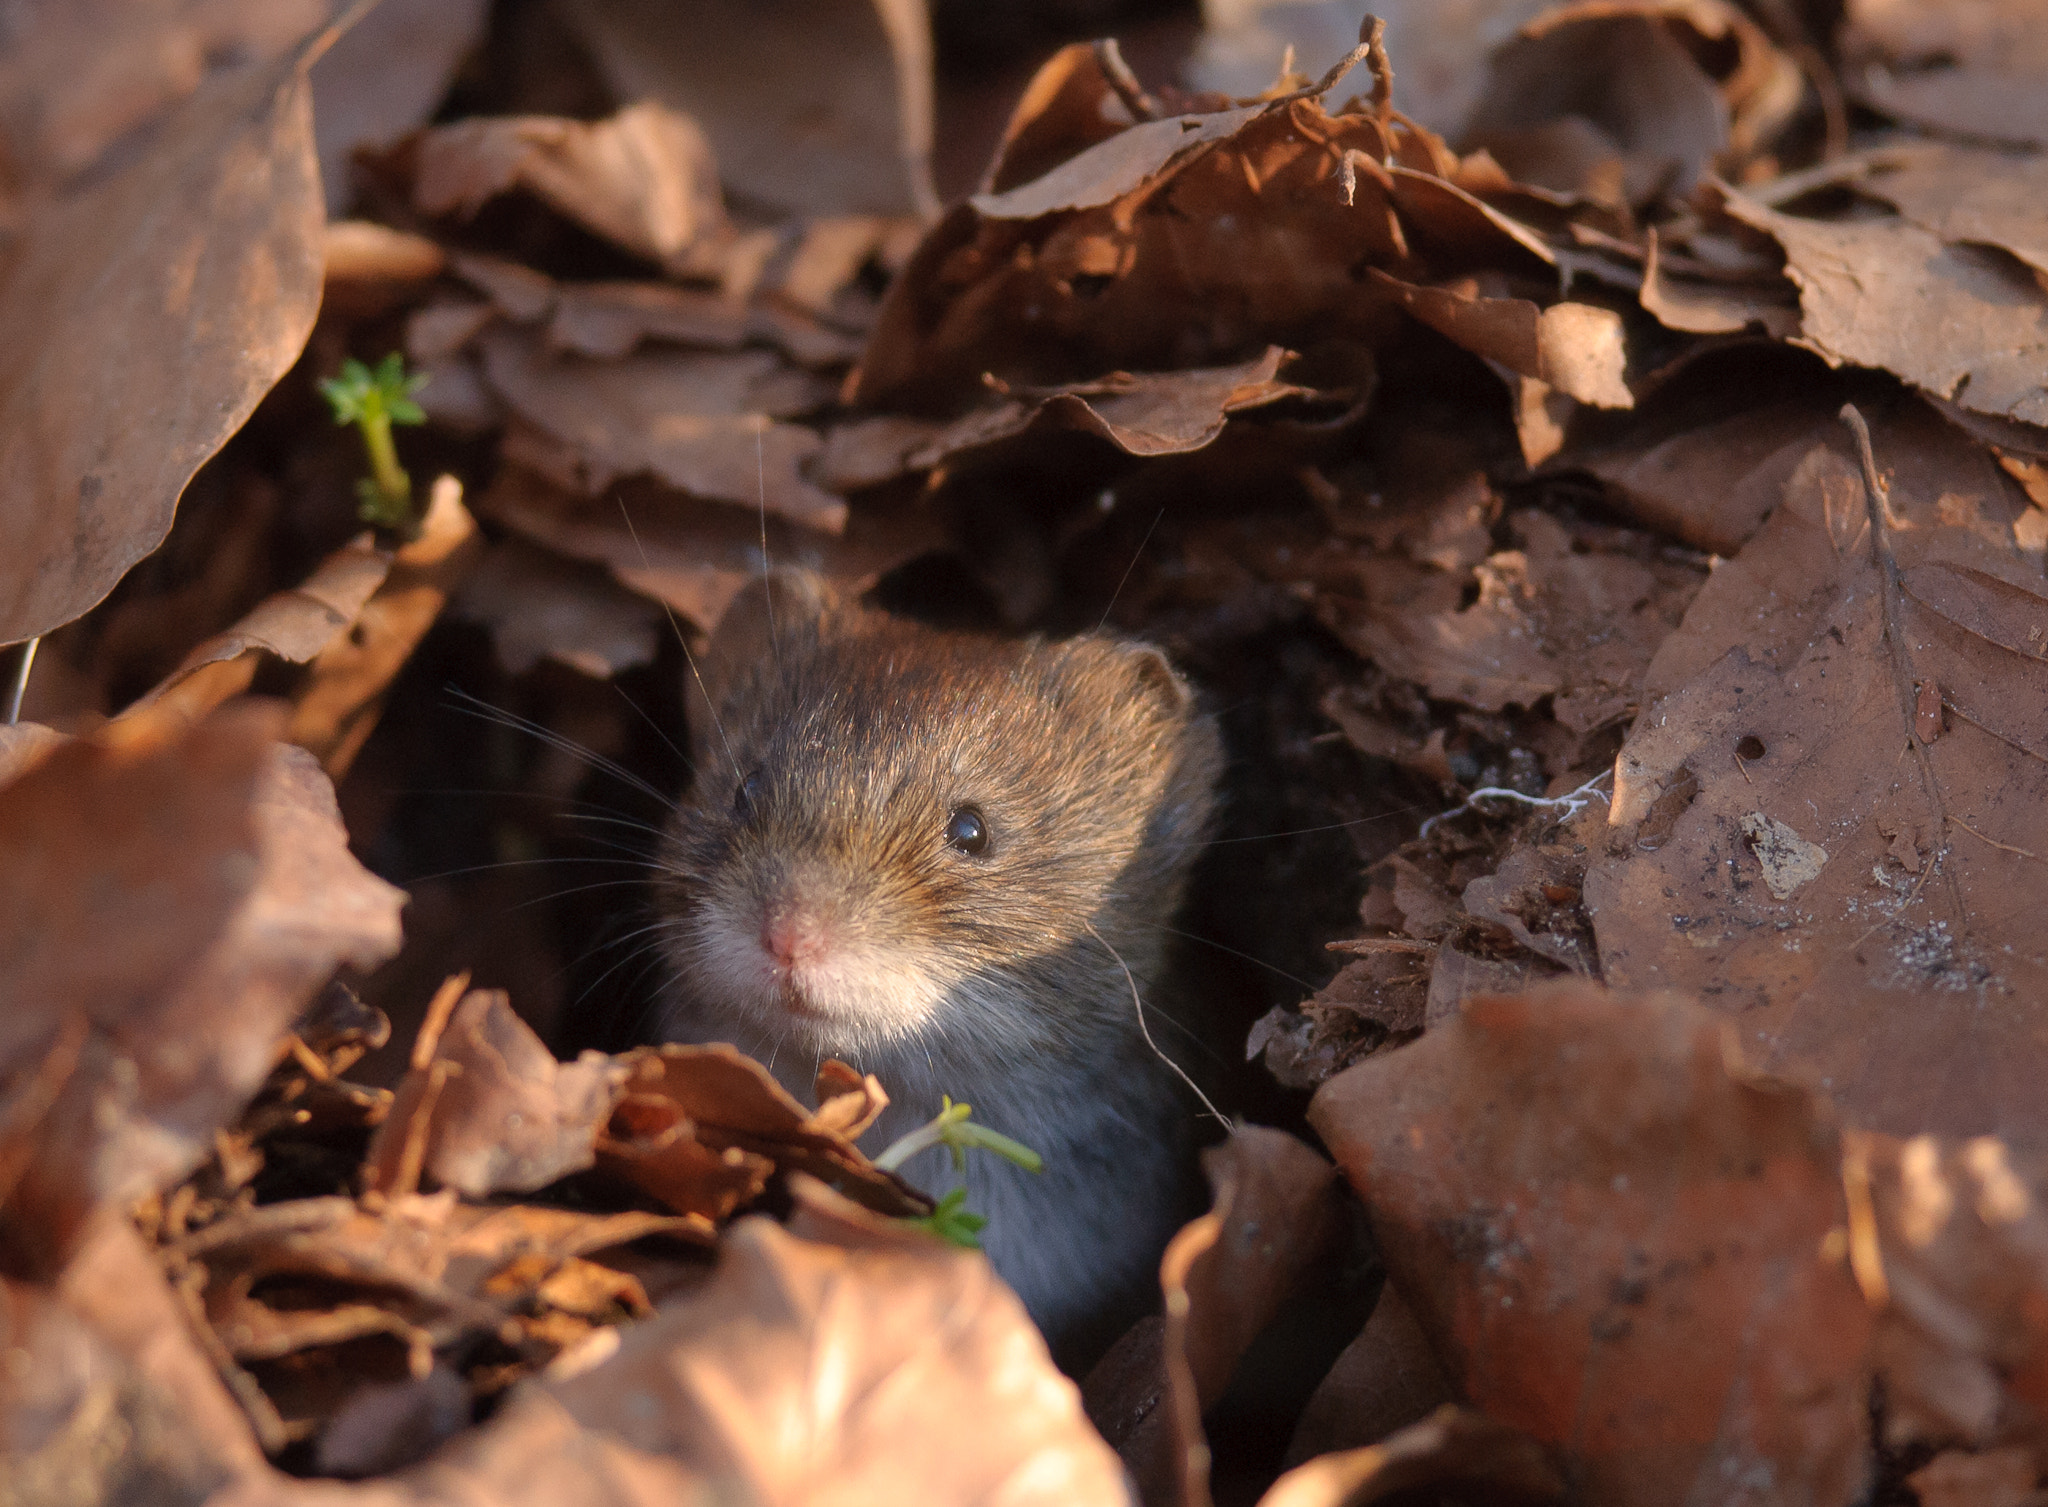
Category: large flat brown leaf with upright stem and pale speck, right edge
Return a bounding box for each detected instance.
[1585,403,2048,1147]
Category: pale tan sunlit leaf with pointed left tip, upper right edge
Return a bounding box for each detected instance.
[1726,192,2048,424]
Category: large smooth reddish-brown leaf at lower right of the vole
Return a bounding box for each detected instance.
[1309,983,1872,1505]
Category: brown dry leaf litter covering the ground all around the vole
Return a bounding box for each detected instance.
[0,0,2048,1507]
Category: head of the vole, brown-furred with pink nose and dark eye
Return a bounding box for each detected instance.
[664,581,1221,1061]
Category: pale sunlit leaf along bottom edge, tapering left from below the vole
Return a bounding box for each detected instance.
[192,1218,1130,1507]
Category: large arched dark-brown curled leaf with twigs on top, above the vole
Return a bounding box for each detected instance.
[854,39,1556,410]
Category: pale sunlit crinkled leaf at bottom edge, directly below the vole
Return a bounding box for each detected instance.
[505,1218,1128,1507]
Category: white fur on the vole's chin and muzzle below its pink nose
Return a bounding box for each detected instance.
[680,903,961,1054]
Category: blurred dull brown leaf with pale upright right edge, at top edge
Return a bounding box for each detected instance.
[563,0,938,215]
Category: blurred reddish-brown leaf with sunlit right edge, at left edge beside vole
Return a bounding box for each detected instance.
[0,708,403,1267]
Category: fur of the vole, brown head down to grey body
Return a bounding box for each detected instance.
[659,573,1223,1339]
